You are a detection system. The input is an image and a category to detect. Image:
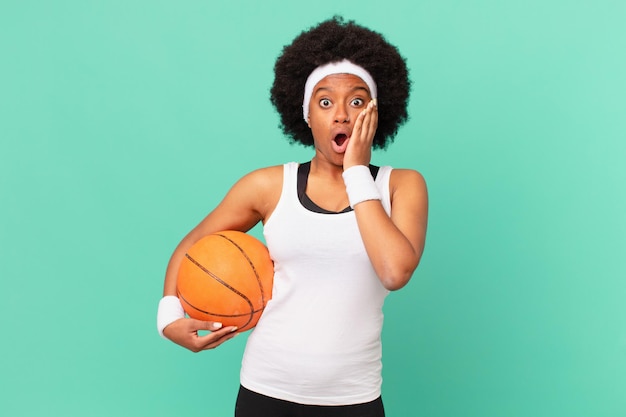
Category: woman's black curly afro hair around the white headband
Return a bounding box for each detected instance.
[270,16,411,149]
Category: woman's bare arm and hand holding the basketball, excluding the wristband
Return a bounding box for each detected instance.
[163,166,283,352]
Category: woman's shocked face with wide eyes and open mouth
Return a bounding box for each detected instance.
[308,74,371,166]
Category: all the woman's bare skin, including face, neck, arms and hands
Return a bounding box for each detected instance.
[163,74,428,352]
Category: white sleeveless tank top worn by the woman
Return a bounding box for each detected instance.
[241,162,391,405]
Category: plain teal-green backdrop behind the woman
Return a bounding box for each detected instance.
[0,0,626,417]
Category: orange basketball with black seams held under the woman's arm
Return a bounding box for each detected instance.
[177,230,274,332]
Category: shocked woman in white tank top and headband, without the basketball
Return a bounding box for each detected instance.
[158,18,428,417]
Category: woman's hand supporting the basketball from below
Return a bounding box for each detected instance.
[163,318,237,352]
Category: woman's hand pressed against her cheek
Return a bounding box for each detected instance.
[343,99,378,171]
